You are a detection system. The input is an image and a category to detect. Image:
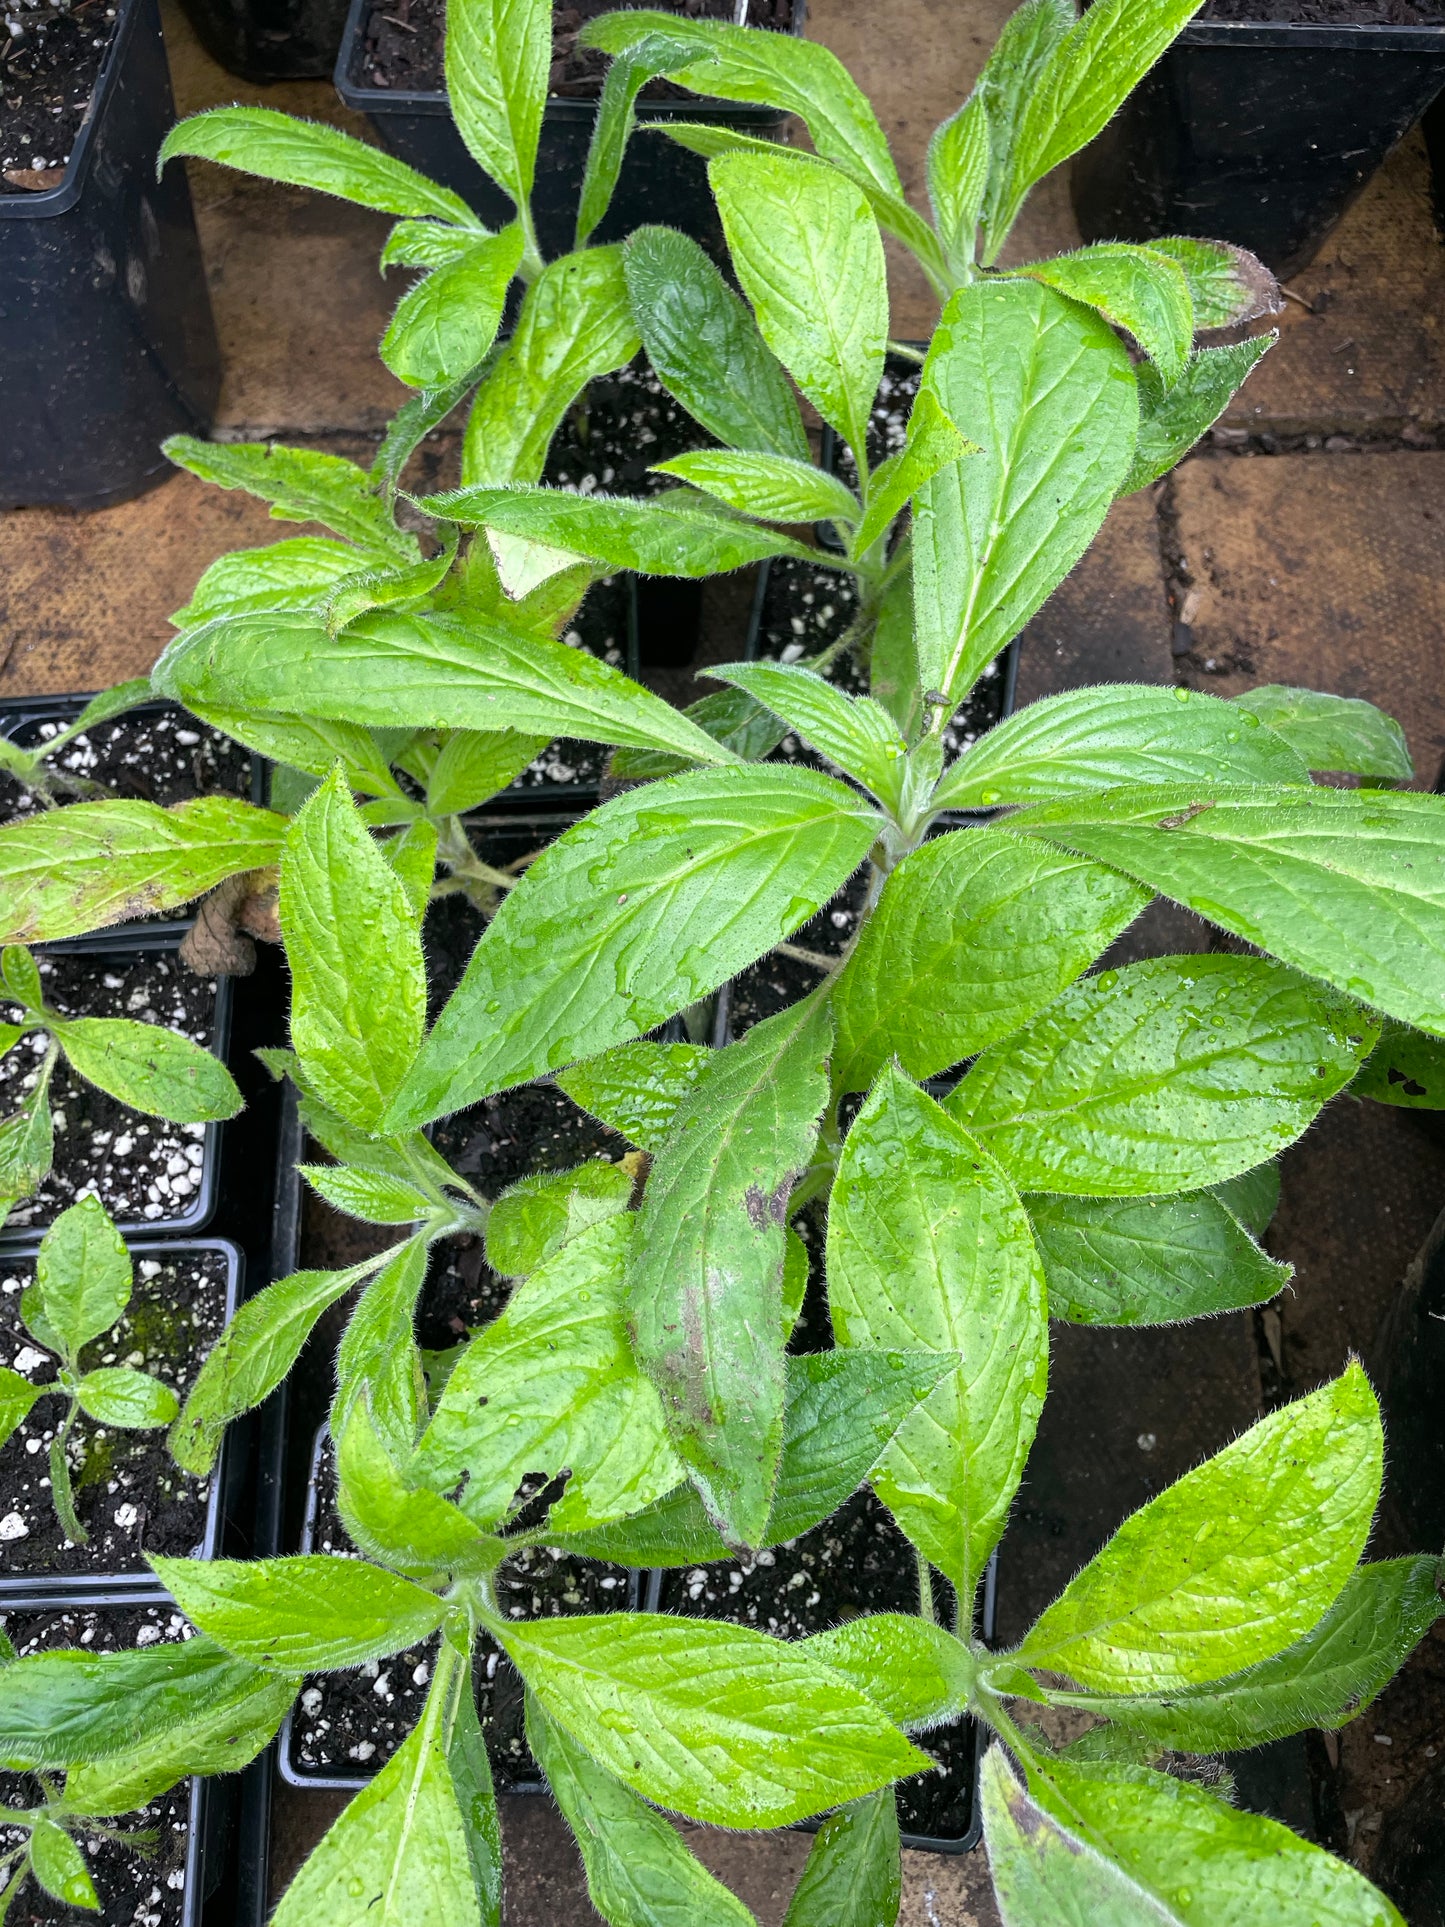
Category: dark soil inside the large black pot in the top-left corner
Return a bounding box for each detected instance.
[0,0,116,193]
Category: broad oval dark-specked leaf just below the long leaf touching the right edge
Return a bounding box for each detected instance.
[948,954,1376,1197]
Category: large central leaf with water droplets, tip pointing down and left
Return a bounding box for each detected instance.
[387,769,879,1129]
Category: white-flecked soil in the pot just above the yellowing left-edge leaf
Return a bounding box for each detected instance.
[0,709,250,823]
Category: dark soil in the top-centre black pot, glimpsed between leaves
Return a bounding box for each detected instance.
[353,0,792,100]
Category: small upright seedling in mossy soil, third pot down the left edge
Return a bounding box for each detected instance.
[0,1199,181,1545]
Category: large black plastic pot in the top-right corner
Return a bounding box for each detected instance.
[1073,19,1445,276]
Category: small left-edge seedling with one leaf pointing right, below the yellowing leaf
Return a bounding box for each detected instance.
[0,944,245,1224]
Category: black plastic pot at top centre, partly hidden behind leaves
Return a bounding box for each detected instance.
[335,0,805,264]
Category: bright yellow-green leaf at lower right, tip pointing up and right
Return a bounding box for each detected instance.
[1015,1364,1383,1694]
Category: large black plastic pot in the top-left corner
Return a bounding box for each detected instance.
[0,0,222,509]
